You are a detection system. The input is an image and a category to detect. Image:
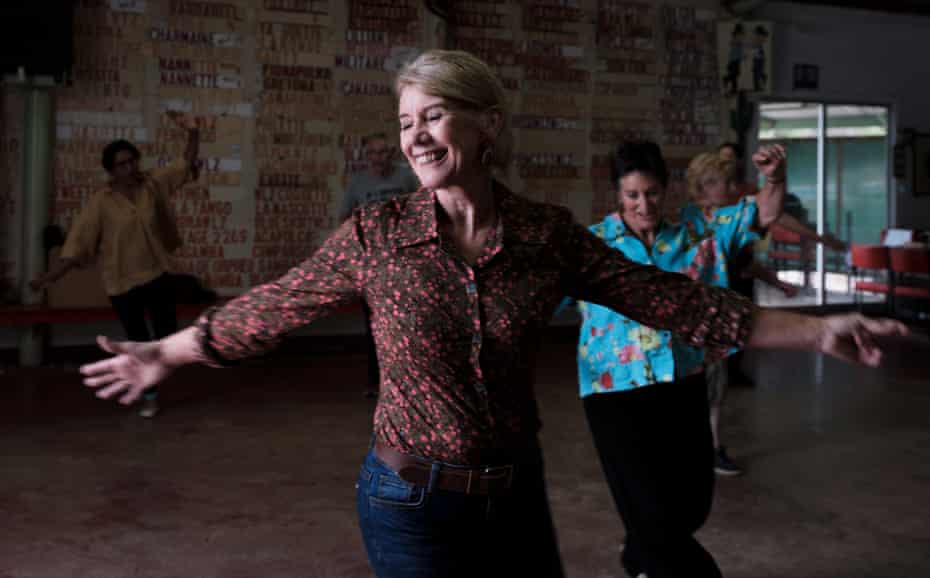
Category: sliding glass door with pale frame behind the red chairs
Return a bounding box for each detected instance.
[757,102,889,307]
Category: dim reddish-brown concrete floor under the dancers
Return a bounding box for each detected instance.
[0,338,930,578]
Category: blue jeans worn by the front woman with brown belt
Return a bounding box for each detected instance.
[357,449,564,578]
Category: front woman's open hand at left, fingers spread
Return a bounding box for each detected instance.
[81,336,174,405]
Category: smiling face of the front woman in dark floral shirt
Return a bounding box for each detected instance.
[398,86,489,189]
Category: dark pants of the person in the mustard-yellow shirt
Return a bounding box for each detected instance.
[110,274,178,399]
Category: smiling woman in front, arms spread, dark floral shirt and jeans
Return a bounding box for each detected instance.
[81,50,904,578]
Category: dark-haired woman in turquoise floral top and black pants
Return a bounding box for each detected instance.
[578,142,785,578]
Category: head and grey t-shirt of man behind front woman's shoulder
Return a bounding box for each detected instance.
[339,133,420,221]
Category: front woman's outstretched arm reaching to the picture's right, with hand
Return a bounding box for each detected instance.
[569,213,907,366]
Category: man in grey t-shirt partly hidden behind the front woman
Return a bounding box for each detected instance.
[339,133,420,397]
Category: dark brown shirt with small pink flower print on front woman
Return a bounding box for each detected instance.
[197,184,753,465]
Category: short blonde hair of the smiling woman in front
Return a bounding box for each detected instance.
[394,50,513,169]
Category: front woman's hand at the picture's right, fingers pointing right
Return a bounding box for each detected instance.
[819,313,907,367]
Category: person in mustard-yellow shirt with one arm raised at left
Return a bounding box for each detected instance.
[30,112,200,418]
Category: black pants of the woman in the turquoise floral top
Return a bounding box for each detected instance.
[584,376,721,578]
